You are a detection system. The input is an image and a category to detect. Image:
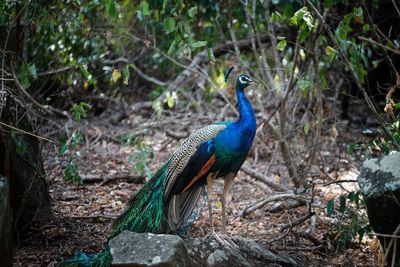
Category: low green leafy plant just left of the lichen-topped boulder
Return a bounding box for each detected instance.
[326,191,372,251]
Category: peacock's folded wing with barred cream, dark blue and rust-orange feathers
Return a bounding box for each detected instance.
[161,123,227,231]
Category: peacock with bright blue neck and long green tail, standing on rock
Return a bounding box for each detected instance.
[64,72,256,267]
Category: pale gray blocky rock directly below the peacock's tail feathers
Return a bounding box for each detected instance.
[109,231,193,267]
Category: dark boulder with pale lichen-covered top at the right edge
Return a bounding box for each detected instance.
[358,152,400,266]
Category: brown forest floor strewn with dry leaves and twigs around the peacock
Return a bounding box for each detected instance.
[14,97,375,266]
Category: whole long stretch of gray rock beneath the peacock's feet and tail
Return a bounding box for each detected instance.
[109,231,308,267]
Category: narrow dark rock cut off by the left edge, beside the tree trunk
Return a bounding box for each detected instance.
[0,175,12,267]
